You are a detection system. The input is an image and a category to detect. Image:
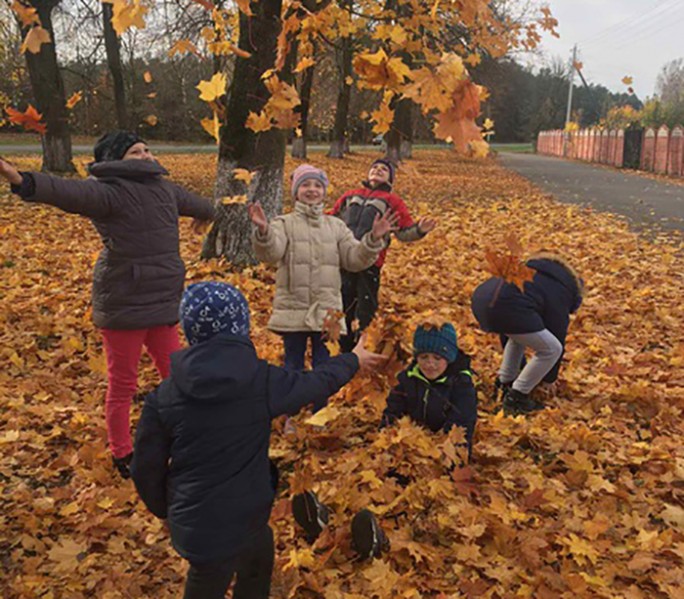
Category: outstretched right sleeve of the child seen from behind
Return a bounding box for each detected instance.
[267,353,359,418]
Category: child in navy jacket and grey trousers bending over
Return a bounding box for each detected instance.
[472,253,583,415]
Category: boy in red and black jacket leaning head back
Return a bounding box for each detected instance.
[330,158,437,352]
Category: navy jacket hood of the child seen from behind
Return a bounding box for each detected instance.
[171,333,259,403]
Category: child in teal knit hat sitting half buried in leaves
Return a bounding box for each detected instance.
[292,323,477,559]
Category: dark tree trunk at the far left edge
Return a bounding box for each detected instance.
[23,0,76,173]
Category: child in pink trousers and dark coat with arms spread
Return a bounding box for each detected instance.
[0,131,214,478]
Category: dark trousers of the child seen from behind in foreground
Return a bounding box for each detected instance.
[183,526,275,599]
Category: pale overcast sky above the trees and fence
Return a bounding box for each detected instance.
[527,0,684,100]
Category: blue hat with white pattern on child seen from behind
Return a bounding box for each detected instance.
[180,281,249,345]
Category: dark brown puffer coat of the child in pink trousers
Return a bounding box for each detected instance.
[13,160,214,329]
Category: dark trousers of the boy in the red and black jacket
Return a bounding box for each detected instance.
[340,265,380,352]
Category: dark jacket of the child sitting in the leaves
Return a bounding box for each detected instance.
[382,352,477,453]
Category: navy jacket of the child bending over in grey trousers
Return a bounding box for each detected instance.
[471,258,582,382]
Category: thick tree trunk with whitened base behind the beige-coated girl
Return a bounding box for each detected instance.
[202,0,286,267]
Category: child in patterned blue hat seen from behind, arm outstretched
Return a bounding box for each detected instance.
[131,282,384,599]
